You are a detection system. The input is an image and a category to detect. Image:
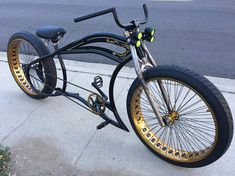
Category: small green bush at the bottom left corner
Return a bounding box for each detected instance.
[0,145,10,176]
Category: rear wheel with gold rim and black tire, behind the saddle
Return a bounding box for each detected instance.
[7,31,57,99]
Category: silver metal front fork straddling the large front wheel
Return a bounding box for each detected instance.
[130,43,172,127]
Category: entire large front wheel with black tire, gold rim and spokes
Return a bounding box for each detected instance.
[127,66,233,168]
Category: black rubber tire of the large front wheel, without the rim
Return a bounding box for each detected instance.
[127,65,233,168]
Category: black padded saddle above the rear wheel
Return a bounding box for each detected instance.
[36,25,66,42]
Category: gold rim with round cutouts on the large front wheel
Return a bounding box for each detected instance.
[131,78,218,163]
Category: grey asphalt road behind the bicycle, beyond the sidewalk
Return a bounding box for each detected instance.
[0,0,235,79]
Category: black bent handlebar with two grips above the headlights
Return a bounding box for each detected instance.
[74,4,148,28]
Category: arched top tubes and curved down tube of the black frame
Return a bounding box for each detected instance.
[58,33,132,131]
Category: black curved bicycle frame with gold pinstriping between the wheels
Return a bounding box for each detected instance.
[29,33,132,131]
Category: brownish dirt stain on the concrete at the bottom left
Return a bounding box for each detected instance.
[9,137,140,176]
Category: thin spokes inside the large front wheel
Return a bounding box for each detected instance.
[132,76,216,162]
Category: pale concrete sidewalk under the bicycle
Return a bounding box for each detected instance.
[0,53,235,176]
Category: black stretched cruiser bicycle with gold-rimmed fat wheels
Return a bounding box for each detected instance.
[7,4,233,167]
